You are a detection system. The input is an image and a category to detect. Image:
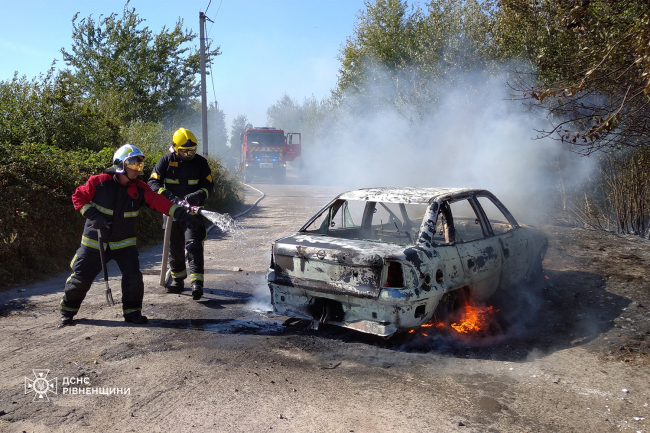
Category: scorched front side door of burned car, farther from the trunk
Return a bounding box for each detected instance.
[476,195,530,287]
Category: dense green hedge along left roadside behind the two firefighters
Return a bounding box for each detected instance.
[0,144,239,288]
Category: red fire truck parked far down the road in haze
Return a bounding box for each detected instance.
[240,126,301,182]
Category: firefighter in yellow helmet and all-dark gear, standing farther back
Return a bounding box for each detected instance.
[149,128,214,300]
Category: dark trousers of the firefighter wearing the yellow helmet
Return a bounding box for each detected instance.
[166,217,208,286]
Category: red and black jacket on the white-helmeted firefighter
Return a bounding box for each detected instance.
[72,173,183,250]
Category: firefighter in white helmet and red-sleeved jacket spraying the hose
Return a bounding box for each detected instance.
[60,143,199,325]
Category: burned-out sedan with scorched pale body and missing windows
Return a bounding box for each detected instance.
[267,188,548,337]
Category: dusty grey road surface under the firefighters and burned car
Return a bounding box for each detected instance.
[0,179,650,433]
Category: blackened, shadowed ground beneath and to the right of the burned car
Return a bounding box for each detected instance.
[274,271,630,362]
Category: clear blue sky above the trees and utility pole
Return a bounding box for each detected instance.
[0,0,364,129]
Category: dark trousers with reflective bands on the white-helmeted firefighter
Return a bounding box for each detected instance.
[60,245,144,316]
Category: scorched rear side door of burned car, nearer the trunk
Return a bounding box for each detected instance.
[443,198,503,300]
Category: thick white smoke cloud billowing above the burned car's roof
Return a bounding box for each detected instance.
[305,66,593,223]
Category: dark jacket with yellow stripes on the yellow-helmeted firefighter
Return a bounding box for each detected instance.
[149,152,214,205]
